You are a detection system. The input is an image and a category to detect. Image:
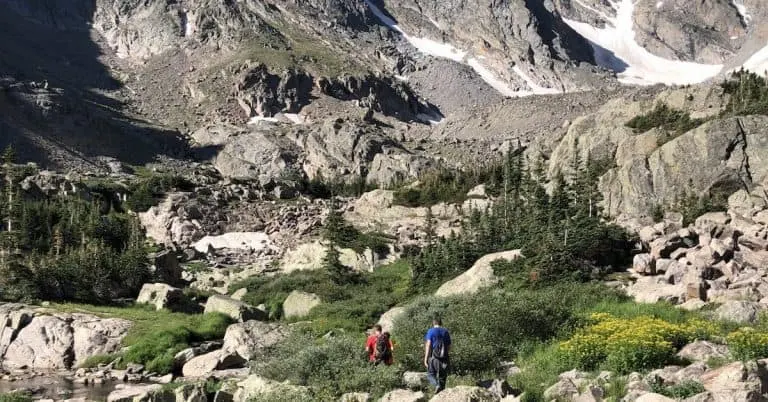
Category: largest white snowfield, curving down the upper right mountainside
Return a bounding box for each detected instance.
[563,0,723,85]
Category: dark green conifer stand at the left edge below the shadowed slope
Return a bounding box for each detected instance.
[0,148,151,303]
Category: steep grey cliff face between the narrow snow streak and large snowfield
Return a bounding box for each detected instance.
[368,0,608,94]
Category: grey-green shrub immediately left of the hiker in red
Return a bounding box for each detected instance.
[254,333,401,400]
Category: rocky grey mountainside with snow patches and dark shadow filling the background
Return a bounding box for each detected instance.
[0,0,765,180]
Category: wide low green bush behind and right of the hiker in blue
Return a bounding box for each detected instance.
[393,284,620,374]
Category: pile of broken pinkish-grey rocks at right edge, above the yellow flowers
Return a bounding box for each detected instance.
[627,204,768,308]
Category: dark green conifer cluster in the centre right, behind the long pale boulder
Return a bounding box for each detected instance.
[404,152,631,293]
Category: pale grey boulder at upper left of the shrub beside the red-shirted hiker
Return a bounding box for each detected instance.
[223,320,289,360]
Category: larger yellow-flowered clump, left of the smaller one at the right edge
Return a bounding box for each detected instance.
[560,313,716,371]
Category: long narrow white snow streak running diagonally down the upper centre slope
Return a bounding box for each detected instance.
[365,0,560,97]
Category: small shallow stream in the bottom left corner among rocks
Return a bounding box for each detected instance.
[0,375,118,401]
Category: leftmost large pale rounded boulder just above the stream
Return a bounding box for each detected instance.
[3,316,75,369]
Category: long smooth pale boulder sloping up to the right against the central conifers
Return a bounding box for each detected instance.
[435,250,522,297]
